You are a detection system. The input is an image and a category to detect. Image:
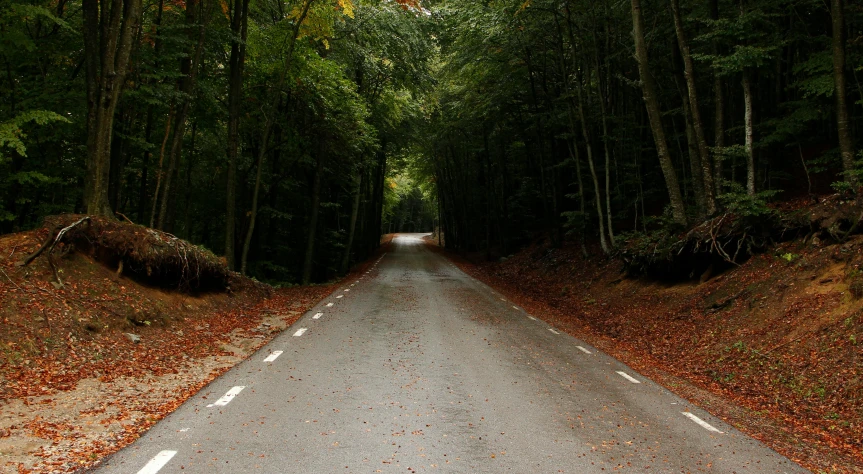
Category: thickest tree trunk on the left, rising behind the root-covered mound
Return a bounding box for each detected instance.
[81,0,141,216]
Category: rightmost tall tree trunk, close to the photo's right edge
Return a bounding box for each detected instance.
[830,0,858,186]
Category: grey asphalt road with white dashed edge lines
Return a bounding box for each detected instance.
[94,235,807,474]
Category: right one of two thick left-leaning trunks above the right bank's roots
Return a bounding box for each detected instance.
[671,0,716,215]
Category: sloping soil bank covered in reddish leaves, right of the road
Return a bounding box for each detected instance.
[428,236,863,473]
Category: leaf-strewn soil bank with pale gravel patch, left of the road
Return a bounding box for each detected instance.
[0,229,378,473]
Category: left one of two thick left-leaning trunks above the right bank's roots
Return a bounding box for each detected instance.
[631,0,686,226]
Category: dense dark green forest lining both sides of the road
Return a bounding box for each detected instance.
[0,0,863,284]
